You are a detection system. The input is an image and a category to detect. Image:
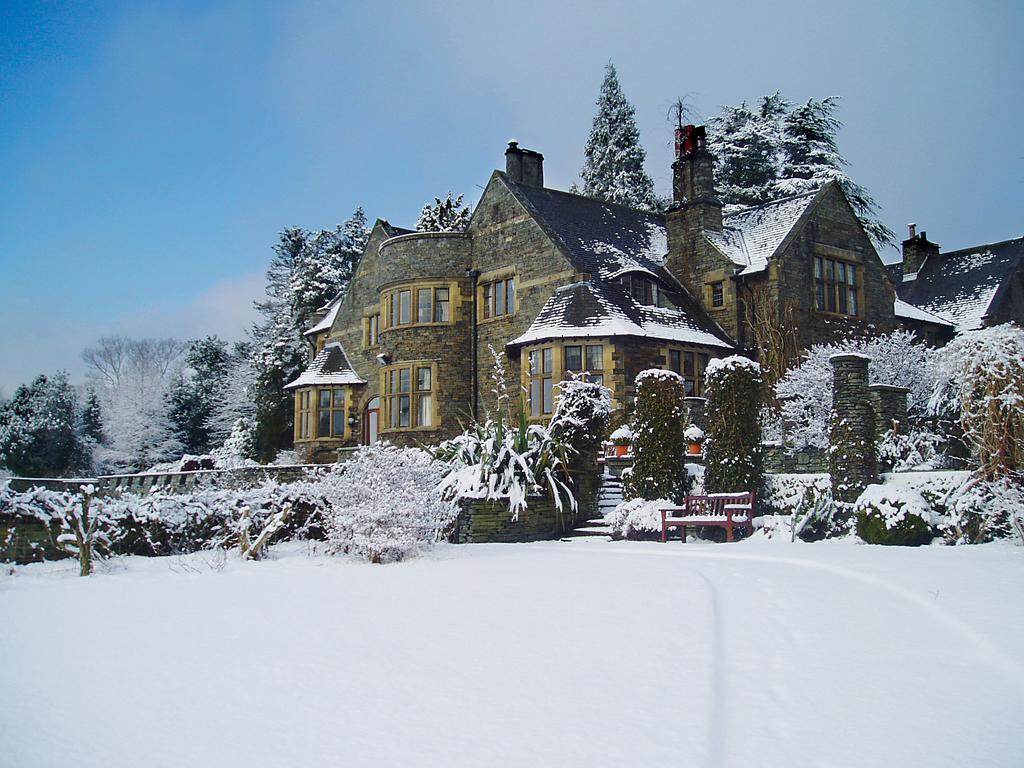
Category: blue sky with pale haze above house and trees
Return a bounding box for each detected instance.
[0,0,1024,395]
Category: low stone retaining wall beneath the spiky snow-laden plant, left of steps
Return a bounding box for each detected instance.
[454,497,573,544]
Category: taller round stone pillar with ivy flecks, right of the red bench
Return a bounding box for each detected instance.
[828,354,879,503]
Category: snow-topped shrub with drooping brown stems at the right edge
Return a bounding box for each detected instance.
[928,325,1024,479]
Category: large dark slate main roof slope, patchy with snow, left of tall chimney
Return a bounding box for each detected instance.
[498,172,675,285]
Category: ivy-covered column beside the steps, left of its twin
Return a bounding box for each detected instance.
[624,369,689,504]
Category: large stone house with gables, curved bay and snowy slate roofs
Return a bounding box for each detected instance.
[288,126,913,461]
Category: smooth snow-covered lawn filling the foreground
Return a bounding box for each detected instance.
[0,541,1024,768]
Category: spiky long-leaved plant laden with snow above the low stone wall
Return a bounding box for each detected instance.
[433,414,577,520]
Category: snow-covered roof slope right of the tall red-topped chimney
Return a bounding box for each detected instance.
[705,191,818,274]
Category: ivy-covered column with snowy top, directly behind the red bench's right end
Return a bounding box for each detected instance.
[703,355,764,494]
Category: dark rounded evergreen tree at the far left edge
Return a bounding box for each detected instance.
[0,373,89,477]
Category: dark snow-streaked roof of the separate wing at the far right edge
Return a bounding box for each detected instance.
[896,238,1024,331]
